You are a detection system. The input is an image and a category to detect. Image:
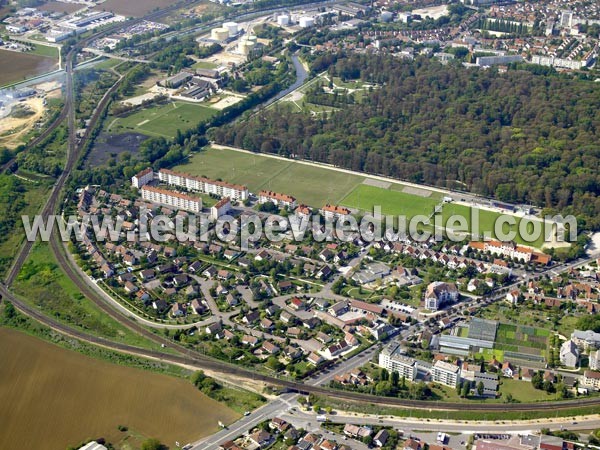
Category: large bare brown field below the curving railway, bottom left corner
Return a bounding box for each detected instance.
[0,329,240,450]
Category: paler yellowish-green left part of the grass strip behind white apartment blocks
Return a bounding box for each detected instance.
[176,148,364,207]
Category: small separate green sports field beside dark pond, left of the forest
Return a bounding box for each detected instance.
[108,102,217,138]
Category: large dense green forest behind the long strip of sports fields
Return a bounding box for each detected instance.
[211,53,600,229]
